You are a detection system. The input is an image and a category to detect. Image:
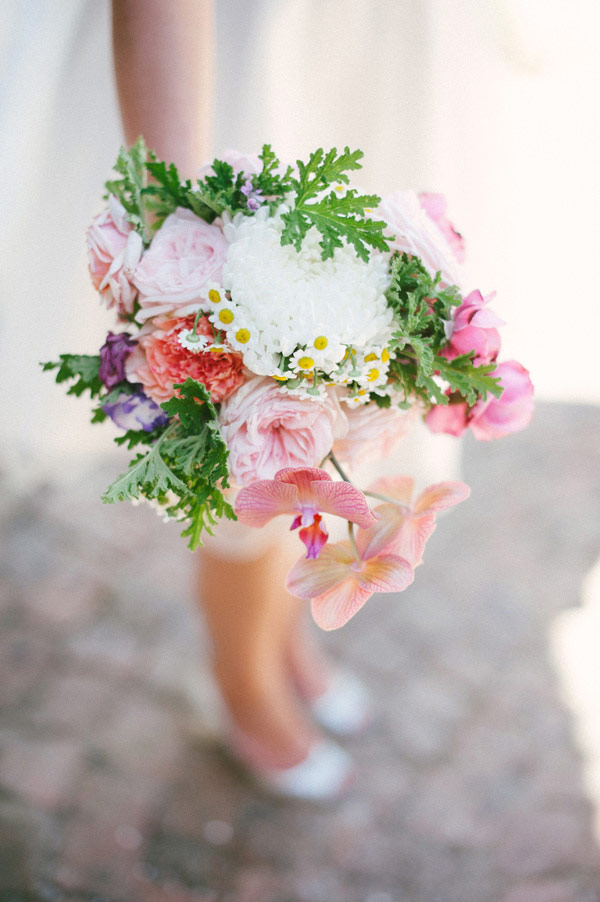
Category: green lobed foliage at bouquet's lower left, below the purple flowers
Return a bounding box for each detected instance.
[102,379,235,550]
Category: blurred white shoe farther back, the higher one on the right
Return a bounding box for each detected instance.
[310,670,372,737]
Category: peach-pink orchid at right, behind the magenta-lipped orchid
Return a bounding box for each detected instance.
[356,476,471,567]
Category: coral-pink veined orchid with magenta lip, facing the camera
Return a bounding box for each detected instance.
[235,467,376,559]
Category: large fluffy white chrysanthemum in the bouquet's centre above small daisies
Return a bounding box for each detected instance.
[220,209,392,375]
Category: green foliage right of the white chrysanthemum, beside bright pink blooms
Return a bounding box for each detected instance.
[384,253,502,405]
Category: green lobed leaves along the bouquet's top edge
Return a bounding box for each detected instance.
[106,138,389,261]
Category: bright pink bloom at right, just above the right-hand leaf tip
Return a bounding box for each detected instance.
[442,291,504,366]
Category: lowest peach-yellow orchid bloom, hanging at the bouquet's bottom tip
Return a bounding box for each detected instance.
[286,527,414,630]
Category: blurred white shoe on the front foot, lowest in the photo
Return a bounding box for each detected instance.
[230,739,356,803]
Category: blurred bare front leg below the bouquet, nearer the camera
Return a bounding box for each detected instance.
[199,546,316,767]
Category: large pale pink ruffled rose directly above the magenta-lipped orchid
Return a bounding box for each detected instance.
[220,376,348,486]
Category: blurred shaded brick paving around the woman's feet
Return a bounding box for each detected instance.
[0,405,600,902]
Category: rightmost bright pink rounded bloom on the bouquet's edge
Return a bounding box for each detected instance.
[469,360,533,441]
